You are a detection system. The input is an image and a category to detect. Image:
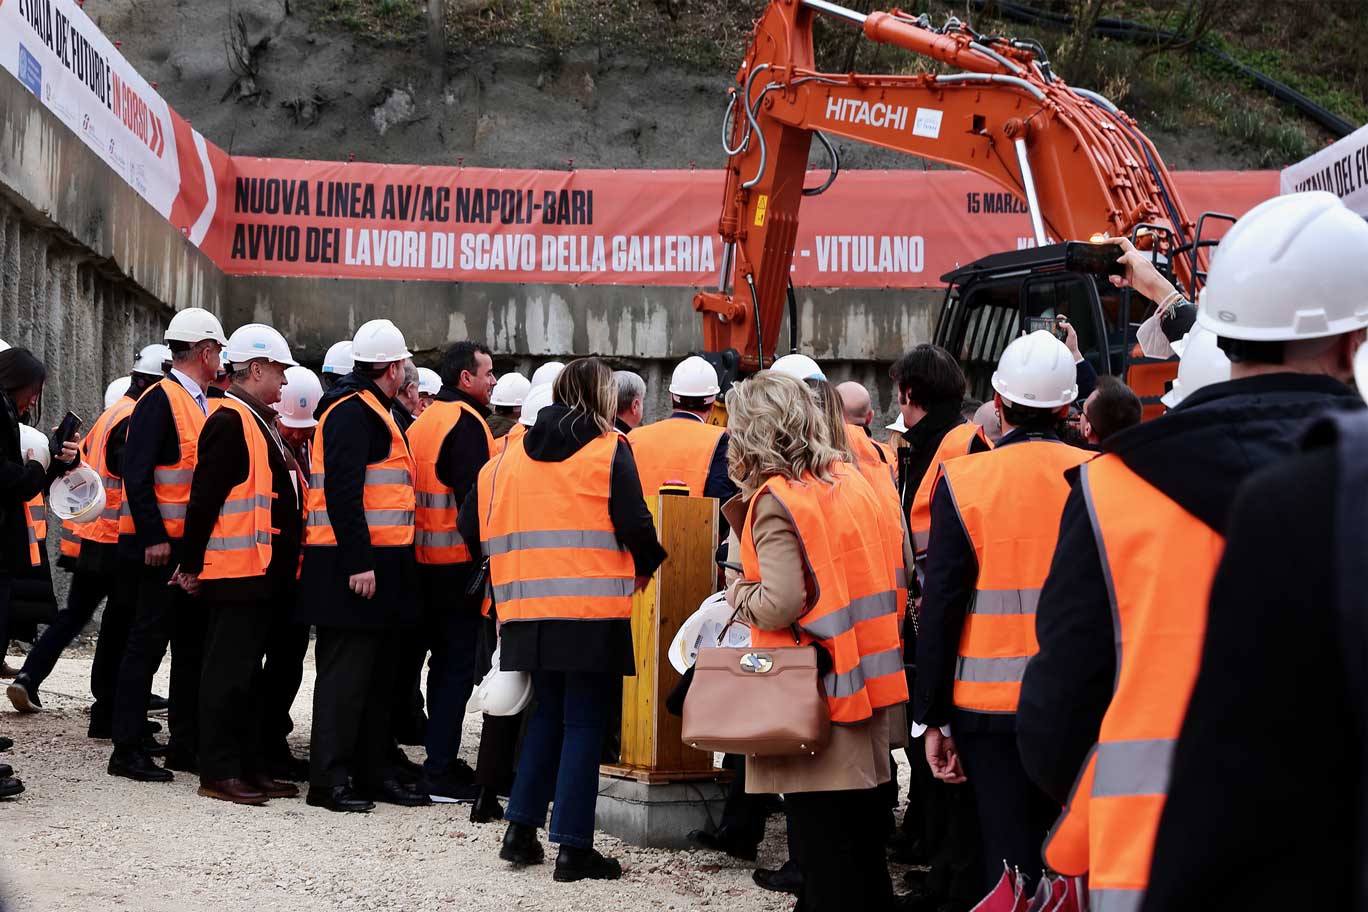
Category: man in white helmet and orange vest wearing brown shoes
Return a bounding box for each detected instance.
[174,323,302,804]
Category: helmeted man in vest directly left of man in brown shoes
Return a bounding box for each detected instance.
[108,308,227,782]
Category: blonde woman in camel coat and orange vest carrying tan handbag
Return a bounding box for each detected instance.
[726,372,907,912]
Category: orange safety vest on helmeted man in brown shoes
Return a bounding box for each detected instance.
[200,397,279,580]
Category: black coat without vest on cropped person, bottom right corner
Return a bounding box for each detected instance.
[1144,415,1368,912]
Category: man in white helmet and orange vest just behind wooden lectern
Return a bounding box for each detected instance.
[627,354,736,503]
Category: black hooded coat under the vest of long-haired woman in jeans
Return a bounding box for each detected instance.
[457,405,666,675]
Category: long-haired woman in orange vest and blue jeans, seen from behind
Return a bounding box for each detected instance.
[457,358,665,881]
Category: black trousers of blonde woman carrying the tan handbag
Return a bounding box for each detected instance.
[784,789,893,912]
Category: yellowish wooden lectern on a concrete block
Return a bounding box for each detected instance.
[601,495,722,785]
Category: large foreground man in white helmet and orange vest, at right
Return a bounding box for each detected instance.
[1018,193,1368,912]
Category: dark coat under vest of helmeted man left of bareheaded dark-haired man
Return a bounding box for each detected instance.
[295,373,421,630]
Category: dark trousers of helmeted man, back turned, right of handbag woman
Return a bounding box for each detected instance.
[955,732,1059,896]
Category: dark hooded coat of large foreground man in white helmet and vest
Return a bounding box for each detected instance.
[1016,373,1363,803]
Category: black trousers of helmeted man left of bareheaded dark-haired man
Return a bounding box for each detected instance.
[317,625,406,789]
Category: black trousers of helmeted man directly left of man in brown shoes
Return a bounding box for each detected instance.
[114,563,208,762]
